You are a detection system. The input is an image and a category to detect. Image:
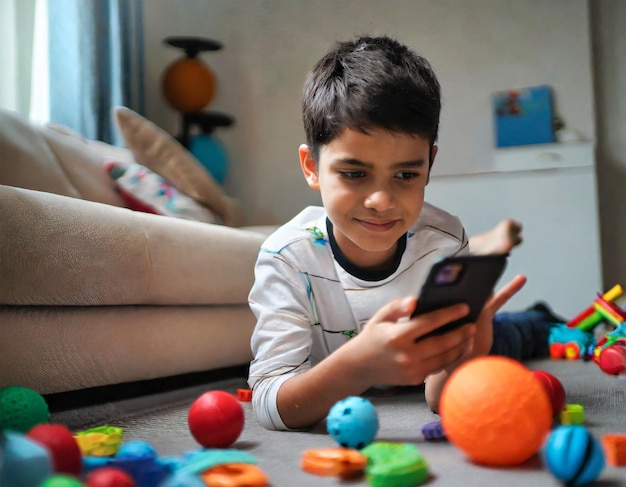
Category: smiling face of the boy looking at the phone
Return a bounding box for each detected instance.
[300,129,437,270]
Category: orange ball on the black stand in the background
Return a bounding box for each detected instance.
[162,57,217,112]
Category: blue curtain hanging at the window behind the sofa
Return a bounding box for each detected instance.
[48,0,144,145]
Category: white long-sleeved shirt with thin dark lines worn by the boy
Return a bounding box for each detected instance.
[248,203,469,430]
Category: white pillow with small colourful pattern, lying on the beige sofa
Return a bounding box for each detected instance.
[104,161,217,223]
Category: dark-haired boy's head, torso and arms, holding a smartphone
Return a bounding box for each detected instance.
[249,37,552,429]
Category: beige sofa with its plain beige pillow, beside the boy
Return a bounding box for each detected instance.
[0,107,270,394]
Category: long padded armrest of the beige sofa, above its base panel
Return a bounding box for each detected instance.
[0,185,265,306]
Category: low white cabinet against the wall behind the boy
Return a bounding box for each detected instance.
[426,143,603,317]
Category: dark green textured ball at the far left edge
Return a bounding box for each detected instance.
[0,386,50,433]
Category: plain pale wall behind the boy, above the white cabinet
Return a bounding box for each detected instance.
[144,0,595,223]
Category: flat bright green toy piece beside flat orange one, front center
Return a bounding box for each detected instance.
[361,441,430,487]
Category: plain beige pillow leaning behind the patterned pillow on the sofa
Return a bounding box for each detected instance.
[114,107,243,226]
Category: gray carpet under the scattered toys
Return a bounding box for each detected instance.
[52,359,626,487]
